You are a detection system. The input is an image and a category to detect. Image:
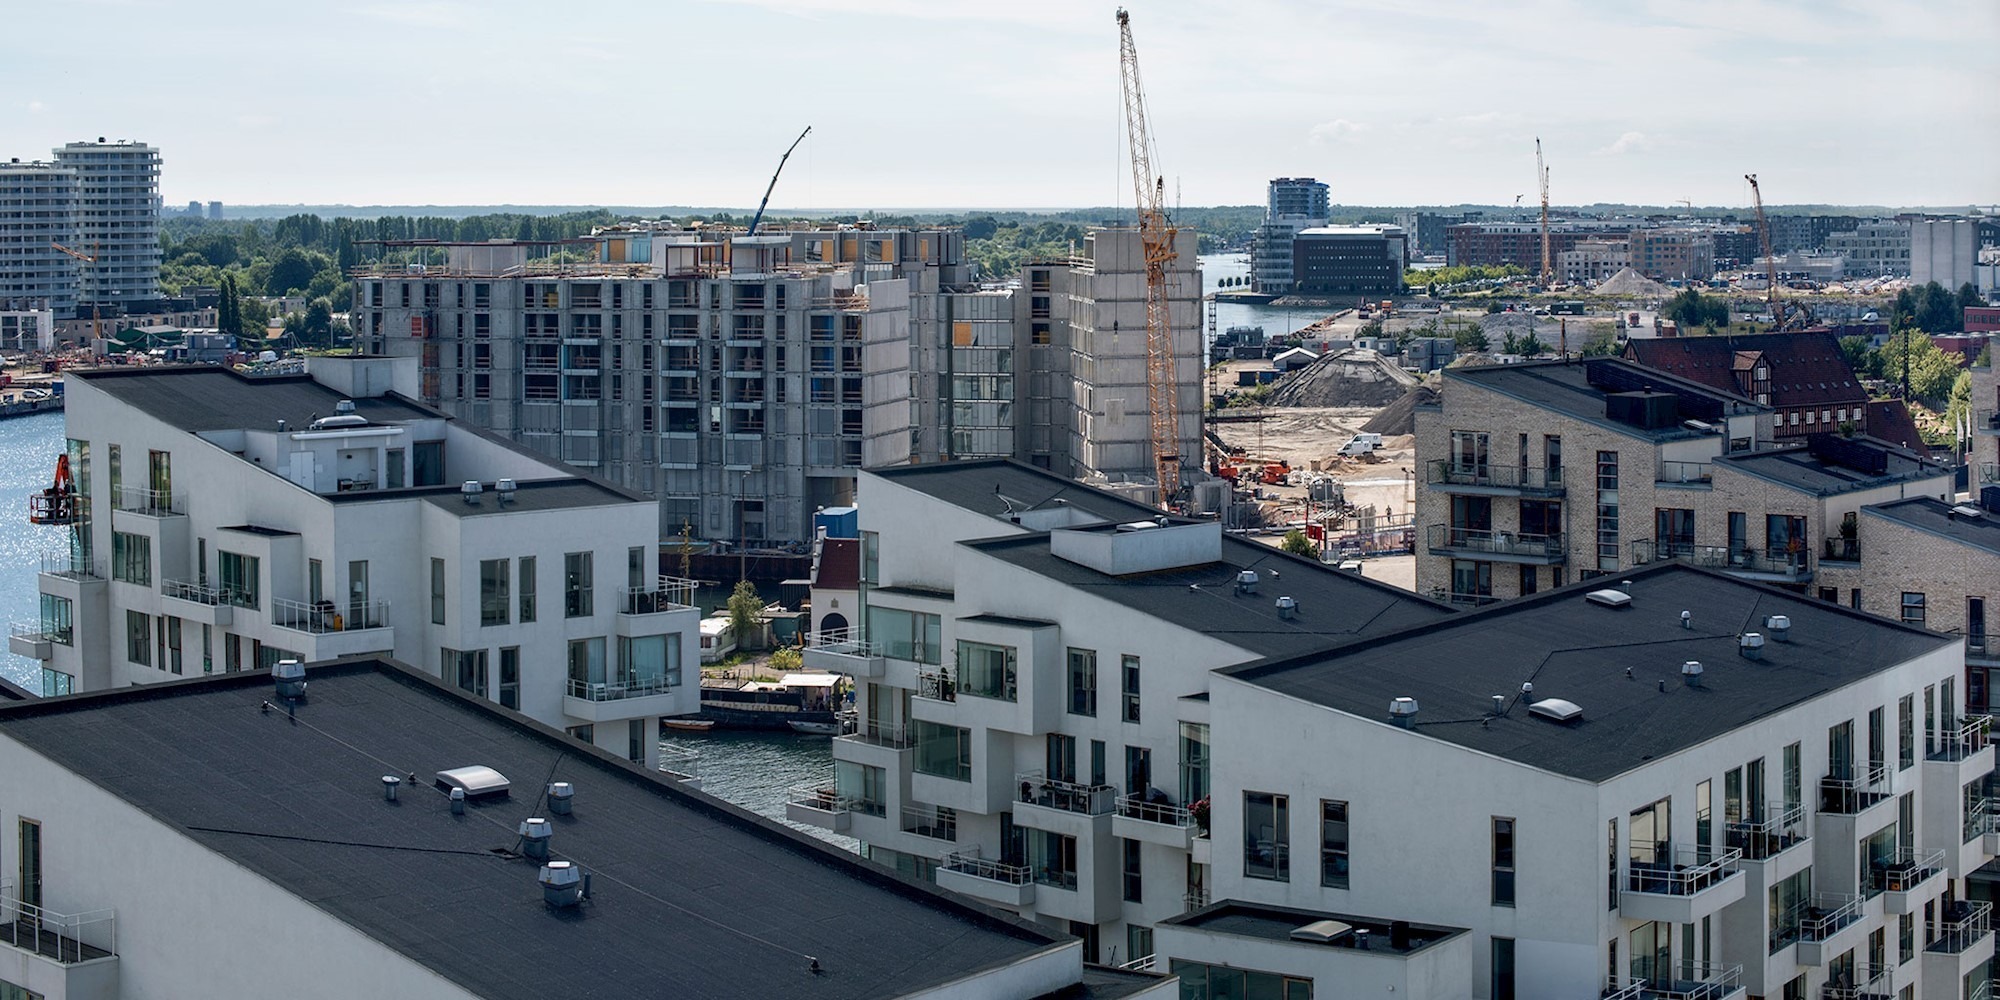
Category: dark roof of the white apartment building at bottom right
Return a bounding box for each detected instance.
[1222,562,1958,782]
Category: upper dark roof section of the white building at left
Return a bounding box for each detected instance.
[64,364,444,432]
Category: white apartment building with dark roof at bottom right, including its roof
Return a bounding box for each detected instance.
[1192,566,2000,1000]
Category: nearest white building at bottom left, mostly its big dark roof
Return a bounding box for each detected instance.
[0,656,1176,1000]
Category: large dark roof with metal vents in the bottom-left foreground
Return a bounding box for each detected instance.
[0,660,1066,998]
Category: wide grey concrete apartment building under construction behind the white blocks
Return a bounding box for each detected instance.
[354,224,1200,546]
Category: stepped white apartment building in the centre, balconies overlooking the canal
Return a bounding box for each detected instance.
[788,462,1448,962]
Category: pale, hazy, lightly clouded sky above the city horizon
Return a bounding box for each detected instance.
[0,0,2000,210]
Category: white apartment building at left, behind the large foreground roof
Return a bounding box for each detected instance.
[10,358,700,764]
